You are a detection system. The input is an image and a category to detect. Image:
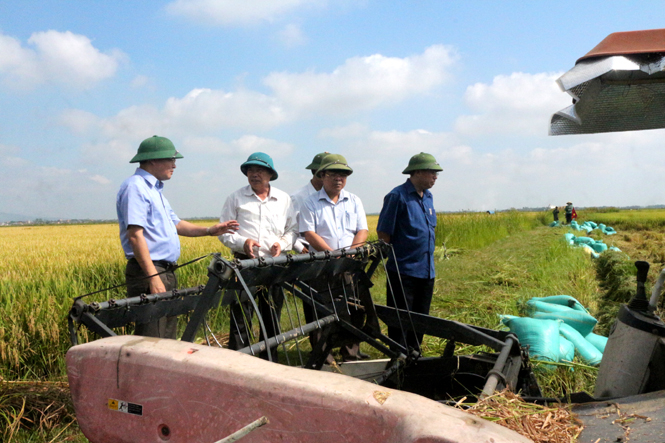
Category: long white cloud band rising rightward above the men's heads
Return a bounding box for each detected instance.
[60,45,457,140]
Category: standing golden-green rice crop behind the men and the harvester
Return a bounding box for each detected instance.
[0,212,540,380]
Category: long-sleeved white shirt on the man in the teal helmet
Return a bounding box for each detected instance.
[219,185,297,257]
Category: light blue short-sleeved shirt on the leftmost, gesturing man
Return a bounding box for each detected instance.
[116,168,180,262]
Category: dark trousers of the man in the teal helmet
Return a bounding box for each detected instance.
[229,285,284,361]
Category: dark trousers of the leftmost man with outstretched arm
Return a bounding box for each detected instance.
[125,259,178,340]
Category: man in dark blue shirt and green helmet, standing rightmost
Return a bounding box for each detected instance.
[376,152,443,351]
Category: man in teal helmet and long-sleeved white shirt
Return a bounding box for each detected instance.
[219,152,297,361]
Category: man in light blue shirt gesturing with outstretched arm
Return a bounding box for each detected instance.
[116,135,238,339]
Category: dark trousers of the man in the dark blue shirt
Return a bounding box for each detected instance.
[386,271,434,350]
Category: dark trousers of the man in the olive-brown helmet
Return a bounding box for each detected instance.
[303,273,365,363]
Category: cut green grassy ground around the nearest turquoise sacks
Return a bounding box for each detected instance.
[424,227,599,397]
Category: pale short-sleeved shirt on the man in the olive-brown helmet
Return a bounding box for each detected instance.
[298,188,367,249]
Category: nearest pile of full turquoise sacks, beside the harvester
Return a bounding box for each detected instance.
[501,295,607,366]
